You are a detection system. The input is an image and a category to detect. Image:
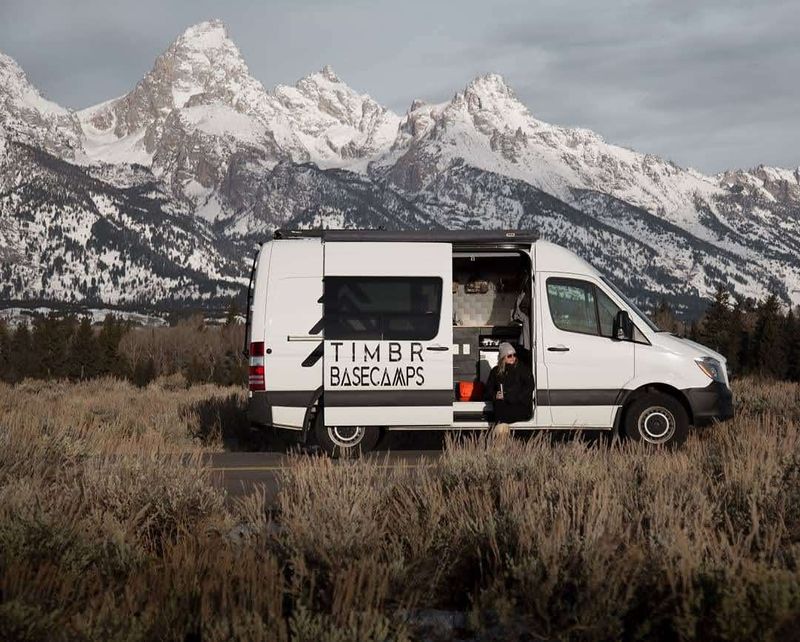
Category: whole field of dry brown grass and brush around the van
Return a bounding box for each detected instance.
[0,380,800,640]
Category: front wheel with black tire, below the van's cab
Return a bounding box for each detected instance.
[622,392,689,448]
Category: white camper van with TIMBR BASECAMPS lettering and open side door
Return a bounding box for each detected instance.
[246,230,733,456]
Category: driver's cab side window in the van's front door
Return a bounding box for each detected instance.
[547,279,619,337]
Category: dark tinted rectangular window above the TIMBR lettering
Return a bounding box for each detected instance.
[324,276,442,341]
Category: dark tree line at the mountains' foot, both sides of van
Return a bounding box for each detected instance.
[0,286,800,386]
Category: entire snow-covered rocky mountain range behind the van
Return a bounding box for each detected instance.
[0,21,800,311]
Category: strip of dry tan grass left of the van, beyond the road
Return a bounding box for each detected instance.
[0,374,246,452]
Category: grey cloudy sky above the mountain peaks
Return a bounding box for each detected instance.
[0,0,800,172]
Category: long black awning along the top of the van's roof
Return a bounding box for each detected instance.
[272,230,539,245]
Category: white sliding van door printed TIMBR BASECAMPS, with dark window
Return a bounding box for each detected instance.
[323,242,454,426]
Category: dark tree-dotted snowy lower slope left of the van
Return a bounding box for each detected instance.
[0,141,244,306]
